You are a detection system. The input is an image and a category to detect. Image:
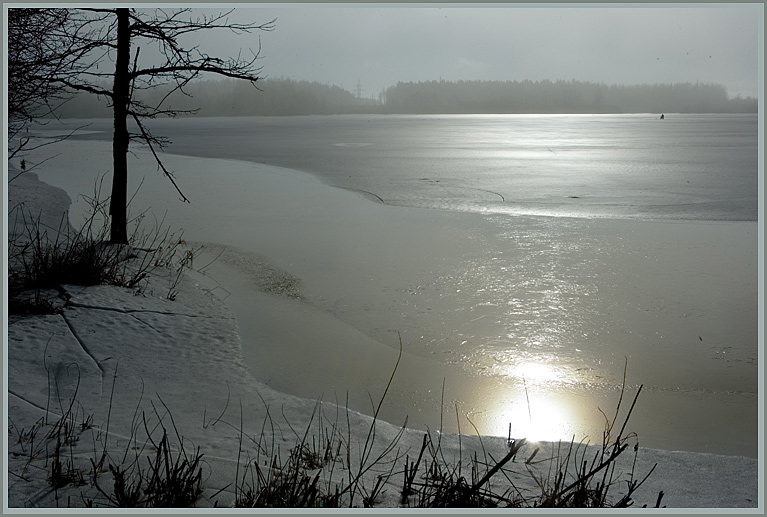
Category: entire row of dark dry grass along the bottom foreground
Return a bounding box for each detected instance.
[9,352,663,508]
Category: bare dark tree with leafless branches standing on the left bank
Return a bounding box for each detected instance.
[40,8,274,244]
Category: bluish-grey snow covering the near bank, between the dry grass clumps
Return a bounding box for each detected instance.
[3,152,763,513]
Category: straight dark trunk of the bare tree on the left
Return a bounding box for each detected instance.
[109,9,130,244]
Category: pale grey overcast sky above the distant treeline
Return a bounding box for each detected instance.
[186,4,763,98]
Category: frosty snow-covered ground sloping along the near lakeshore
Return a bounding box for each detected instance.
[4,166,762,509]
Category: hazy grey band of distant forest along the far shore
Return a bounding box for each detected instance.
[60,79,758,118]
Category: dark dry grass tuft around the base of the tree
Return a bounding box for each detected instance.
[8,177,200,314]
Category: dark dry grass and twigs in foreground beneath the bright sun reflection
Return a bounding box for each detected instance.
[231,348,663,508]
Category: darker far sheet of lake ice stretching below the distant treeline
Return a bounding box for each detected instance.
[69,114,759,221]
